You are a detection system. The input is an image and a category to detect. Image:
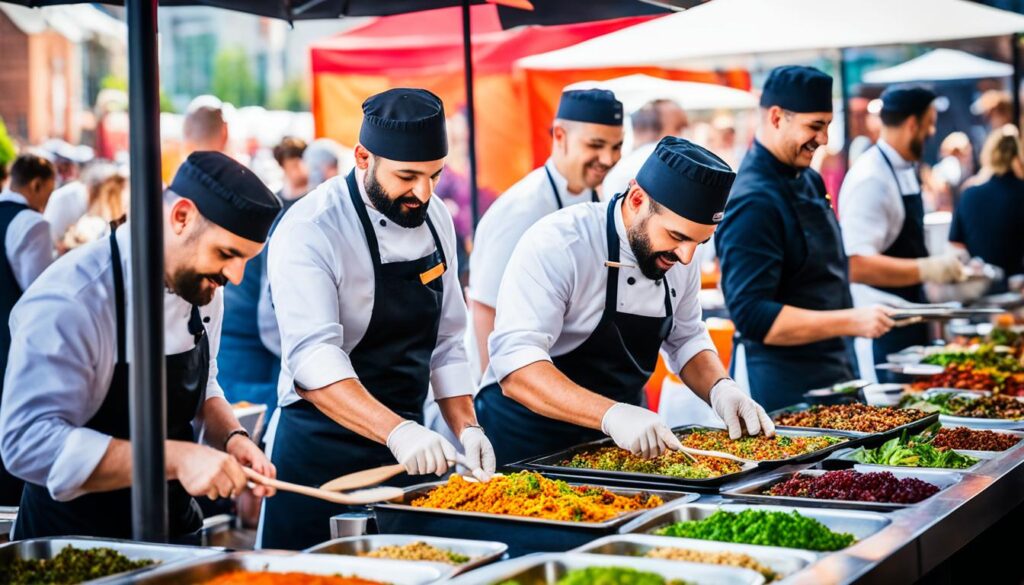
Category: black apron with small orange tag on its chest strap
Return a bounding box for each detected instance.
[261,172,447,549]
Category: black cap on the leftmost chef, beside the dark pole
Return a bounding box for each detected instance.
[169,152,281,243]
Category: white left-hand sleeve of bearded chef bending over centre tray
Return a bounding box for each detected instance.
[487,224,578,382]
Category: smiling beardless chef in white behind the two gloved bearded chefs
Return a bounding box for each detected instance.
[469,89,623,370]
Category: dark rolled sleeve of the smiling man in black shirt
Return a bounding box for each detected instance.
[715,197,785,341]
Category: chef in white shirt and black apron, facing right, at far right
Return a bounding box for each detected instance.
[839,86,965,379]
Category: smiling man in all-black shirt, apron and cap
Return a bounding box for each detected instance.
[715,66,893,410]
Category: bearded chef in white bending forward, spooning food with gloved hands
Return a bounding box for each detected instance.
[477,137,774,464]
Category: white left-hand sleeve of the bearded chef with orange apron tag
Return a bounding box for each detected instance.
[268,221,356,389]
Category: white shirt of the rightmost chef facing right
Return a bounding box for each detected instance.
[839,140,921,256]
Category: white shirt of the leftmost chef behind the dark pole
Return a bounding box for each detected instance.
[0,225,224,501]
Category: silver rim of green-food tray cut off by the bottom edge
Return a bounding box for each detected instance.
[452,553,765,585]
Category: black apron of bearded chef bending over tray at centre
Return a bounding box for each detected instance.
[476,197,675,465]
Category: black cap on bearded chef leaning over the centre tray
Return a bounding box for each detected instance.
[637,136,736,225]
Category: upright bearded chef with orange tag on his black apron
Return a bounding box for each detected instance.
[258,89,495,549]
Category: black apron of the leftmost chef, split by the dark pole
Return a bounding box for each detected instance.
[13,229,210,544]
